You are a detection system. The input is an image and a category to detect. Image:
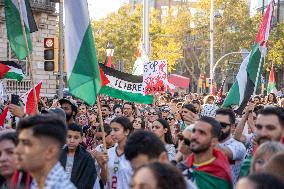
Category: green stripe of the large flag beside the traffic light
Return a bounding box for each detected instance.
[68,25,101,105]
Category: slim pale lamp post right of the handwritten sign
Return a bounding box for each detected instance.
[210,0,214,94]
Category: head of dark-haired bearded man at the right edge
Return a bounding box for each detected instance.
[256,107,284,145]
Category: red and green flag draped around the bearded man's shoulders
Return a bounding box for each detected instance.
[187,150,233,189]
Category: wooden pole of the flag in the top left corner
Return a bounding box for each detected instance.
[18,0,38,112]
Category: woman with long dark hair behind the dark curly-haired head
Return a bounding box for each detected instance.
[152,118,176,161]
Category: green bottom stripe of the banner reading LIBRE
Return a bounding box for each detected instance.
[100,86,153,104]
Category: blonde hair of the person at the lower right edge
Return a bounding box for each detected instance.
[250,142,284,173]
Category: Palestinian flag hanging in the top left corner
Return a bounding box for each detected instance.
[4,0,37,60]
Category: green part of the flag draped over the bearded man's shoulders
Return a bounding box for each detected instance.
[192,170,233,189]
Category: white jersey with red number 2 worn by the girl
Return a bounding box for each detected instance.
[106,146,133,189]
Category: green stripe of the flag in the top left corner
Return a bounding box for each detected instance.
[4,0,32,60]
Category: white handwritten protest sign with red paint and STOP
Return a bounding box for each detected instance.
[142,60,168,95]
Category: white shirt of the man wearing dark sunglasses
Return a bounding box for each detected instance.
[220,138,246,185]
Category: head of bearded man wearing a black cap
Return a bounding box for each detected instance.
[58,98,77,125]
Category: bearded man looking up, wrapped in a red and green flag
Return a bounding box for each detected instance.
[184,116,232,189]
